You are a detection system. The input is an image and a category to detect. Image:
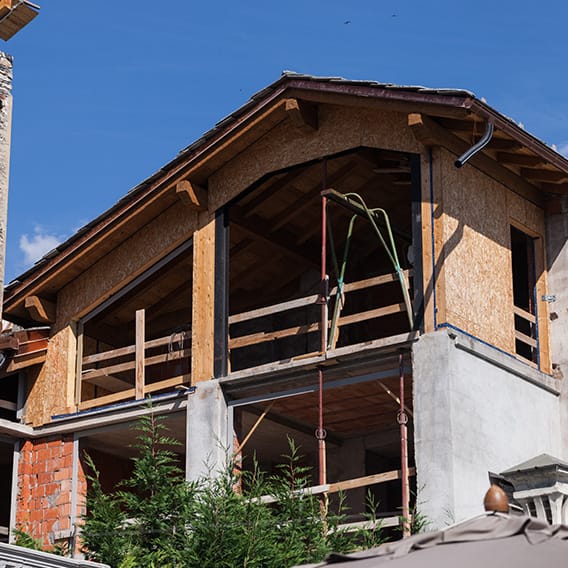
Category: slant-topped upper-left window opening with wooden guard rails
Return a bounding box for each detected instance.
[77,243,193,409]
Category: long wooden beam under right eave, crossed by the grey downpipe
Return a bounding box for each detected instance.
[408,113,543,206]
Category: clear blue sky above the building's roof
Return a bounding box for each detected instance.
[0,0,568,282]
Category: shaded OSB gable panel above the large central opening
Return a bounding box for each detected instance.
[209,105,420,211]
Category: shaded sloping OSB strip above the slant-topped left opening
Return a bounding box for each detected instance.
[57,202,198,326]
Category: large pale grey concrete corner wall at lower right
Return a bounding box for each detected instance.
[413,329,565,528]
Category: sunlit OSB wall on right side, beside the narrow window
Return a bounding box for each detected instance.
[434,150,546,360]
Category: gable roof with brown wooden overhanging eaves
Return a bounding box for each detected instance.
[4,74,568,324]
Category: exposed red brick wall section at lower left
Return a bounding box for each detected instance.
[16,437,86,546]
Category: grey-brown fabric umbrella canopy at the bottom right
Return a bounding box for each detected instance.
[302,513,568,568]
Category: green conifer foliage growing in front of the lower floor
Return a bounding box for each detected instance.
[82,415,388,568]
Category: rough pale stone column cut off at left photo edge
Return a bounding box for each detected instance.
[0,52,12,320]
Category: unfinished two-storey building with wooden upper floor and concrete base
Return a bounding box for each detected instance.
[0,73,568,544]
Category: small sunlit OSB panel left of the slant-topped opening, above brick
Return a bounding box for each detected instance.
[26,326,76,426]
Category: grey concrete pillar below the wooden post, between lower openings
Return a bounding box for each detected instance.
[185,380,232,481]
